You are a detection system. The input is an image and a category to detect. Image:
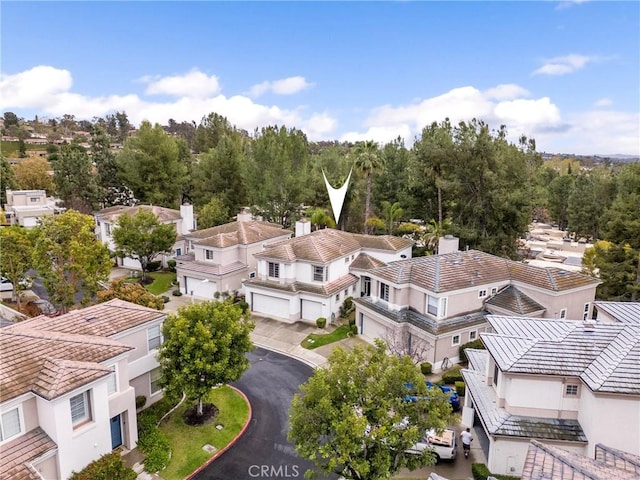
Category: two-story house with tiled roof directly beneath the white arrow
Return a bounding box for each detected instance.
[244,222,413,323]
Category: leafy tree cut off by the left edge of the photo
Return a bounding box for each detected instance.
[0,226,33,307]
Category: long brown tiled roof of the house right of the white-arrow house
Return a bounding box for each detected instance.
[372,250,599,293]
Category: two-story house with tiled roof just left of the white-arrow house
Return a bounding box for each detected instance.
[176,210,292,300]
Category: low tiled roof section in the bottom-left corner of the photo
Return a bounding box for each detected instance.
[0,427,57,480]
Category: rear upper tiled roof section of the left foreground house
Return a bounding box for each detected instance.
[15,298,167,337]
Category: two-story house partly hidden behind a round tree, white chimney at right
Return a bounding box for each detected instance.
[93,204,196,270]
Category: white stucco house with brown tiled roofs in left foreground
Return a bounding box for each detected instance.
[0,300,166,480]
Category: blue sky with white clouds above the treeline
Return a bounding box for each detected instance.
[0,1,640,155]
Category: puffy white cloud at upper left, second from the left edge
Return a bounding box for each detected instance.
[140,69,220,98]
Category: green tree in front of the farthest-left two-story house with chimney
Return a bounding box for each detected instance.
[113,210,178,283]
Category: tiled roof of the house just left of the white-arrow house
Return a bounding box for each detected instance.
[186,220,292,248]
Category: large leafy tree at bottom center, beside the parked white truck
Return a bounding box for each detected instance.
[289,340,451,480]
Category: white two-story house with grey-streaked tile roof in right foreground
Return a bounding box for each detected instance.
[462,315,640,475]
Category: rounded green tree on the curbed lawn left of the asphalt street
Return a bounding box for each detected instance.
[158,301,255,415]
